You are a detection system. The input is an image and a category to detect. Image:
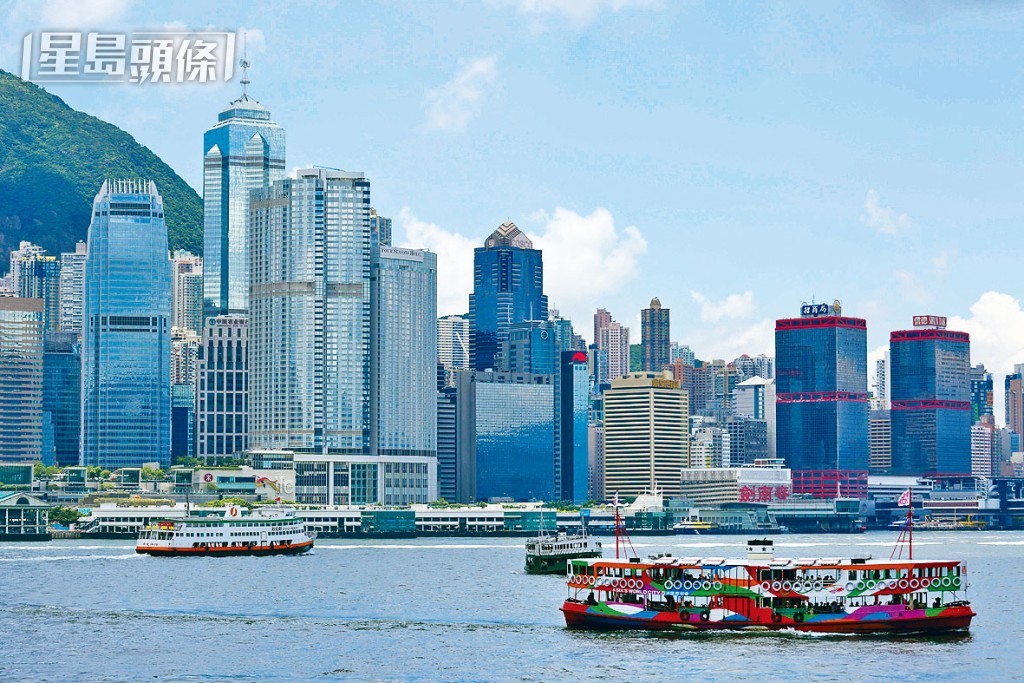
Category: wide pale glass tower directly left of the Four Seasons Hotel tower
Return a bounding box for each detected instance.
[249,168,372,455]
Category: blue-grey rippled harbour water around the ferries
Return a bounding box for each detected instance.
[0,531,1024,681]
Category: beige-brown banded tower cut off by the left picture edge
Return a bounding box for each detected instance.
[0,296,44,462]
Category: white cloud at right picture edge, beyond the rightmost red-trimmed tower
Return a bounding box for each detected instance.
[948,292,1024,423]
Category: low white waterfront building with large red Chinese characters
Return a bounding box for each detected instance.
[680,459,793,506]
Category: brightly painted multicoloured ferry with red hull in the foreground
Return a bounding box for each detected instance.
[562,540,975,633]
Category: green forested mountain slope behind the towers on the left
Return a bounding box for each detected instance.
[0,71,203,273]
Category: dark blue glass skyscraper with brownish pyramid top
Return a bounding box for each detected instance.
[469,221,548,370]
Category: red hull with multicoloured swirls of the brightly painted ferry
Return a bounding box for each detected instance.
[562,600,975,634]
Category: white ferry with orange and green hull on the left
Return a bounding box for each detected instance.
[135,505,316,557]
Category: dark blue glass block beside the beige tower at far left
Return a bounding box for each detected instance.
[43,332,82,467]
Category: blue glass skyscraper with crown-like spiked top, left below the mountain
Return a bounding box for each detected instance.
[82,180,171,468]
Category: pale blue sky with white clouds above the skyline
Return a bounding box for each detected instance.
[0,0,1024,416]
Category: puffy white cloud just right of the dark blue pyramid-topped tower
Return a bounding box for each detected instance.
[529,207,647,338]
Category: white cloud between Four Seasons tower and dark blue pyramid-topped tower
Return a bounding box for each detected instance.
[398,207,482,315]
